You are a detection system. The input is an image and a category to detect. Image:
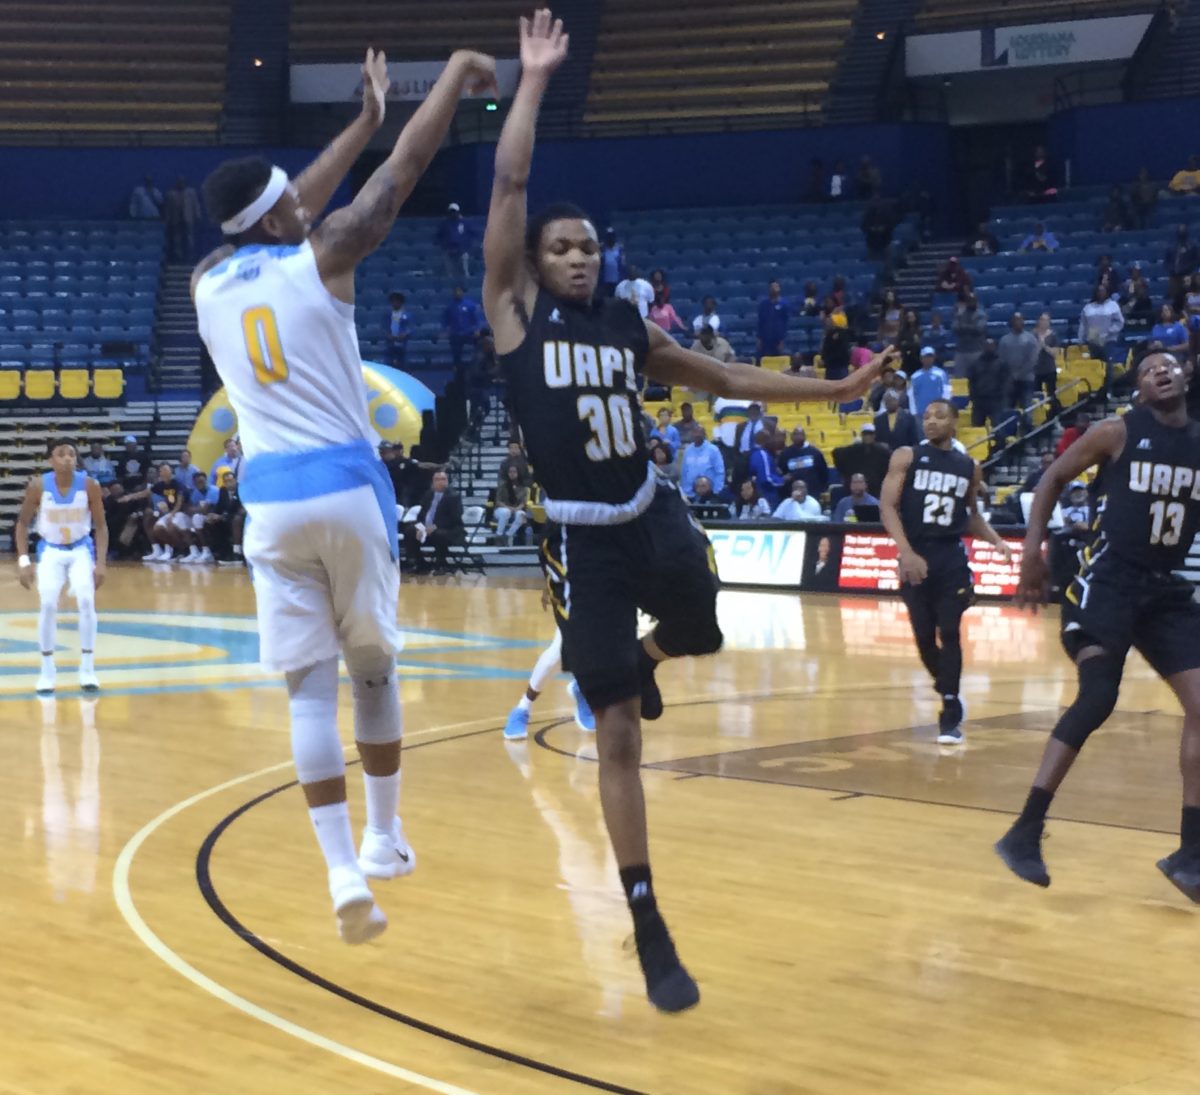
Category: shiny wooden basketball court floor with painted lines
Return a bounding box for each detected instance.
[0,566,1200,1095]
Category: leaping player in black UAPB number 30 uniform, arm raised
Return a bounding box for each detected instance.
[484,11,884,1011]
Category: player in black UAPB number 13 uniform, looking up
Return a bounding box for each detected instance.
[996,353,1200,903]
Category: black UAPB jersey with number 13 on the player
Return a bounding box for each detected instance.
[1088,407,1200,573]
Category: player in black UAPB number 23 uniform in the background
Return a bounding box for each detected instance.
[880,400,1012,746]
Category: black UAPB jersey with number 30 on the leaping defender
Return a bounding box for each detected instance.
[499,291,650,523]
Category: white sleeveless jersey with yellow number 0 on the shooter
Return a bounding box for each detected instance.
[196,241,378,460]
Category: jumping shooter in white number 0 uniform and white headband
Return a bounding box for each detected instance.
[192,50,496,944]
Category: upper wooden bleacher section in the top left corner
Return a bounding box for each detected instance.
[0,0,229,144]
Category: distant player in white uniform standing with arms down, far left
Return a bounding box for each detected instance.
[14,438,108,695]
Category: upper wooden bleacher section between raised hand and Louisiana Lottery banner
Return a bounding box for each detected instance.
[584,0,858,131]
